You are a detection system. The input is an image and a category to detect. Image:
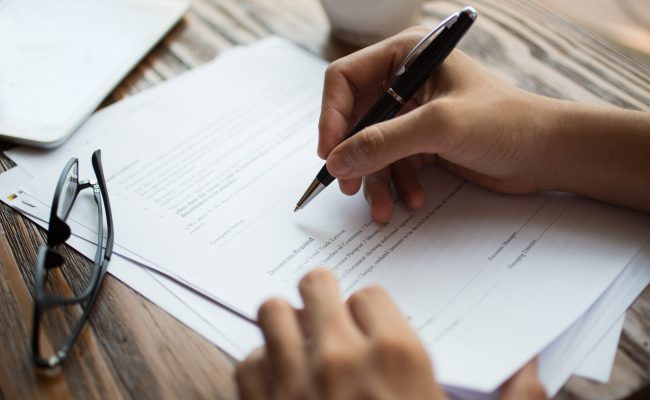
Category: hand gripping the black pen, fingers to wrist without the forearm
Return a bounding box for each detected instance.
[318,28,546,223]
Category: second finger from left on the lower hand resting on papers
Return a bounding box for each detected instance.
[258,299,306,399]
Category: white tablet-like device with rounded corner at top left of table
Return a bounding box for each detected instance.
[0,0,188,147]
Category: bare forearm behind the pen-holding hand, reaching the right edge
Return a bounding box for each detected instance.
[541,100,650,211]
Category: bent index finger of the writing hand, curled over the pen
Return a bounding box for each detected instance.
[318,28,426,158]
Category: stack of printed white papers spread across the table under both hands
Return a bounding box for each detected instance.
[0,38,650,398]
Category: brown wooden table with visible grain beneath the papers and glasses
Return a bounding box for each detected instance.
[0,0,650,399]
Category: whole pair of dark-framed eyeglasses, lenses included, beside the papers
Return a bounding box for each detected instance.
[32,150,113,368]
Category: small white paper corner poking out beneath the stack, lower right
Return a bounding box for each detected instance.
[573,314,625,383]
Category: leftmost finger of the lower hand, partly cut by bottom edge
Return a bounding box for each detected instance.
[235,349,271,400]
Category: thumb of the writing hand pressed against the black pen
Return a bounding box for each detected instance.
[327,103,441,179]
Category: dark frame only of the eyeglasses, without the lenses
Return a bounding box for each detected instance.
[32,149,114,368]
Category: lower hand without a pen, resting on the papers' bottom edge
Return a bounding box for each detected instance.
[236,269,545,400]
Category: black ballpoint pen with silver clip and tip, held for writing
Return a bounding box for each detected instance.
[294,7,478,212]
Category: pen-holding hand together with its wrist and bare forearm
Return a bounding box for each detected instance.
[318,28,650,223]
